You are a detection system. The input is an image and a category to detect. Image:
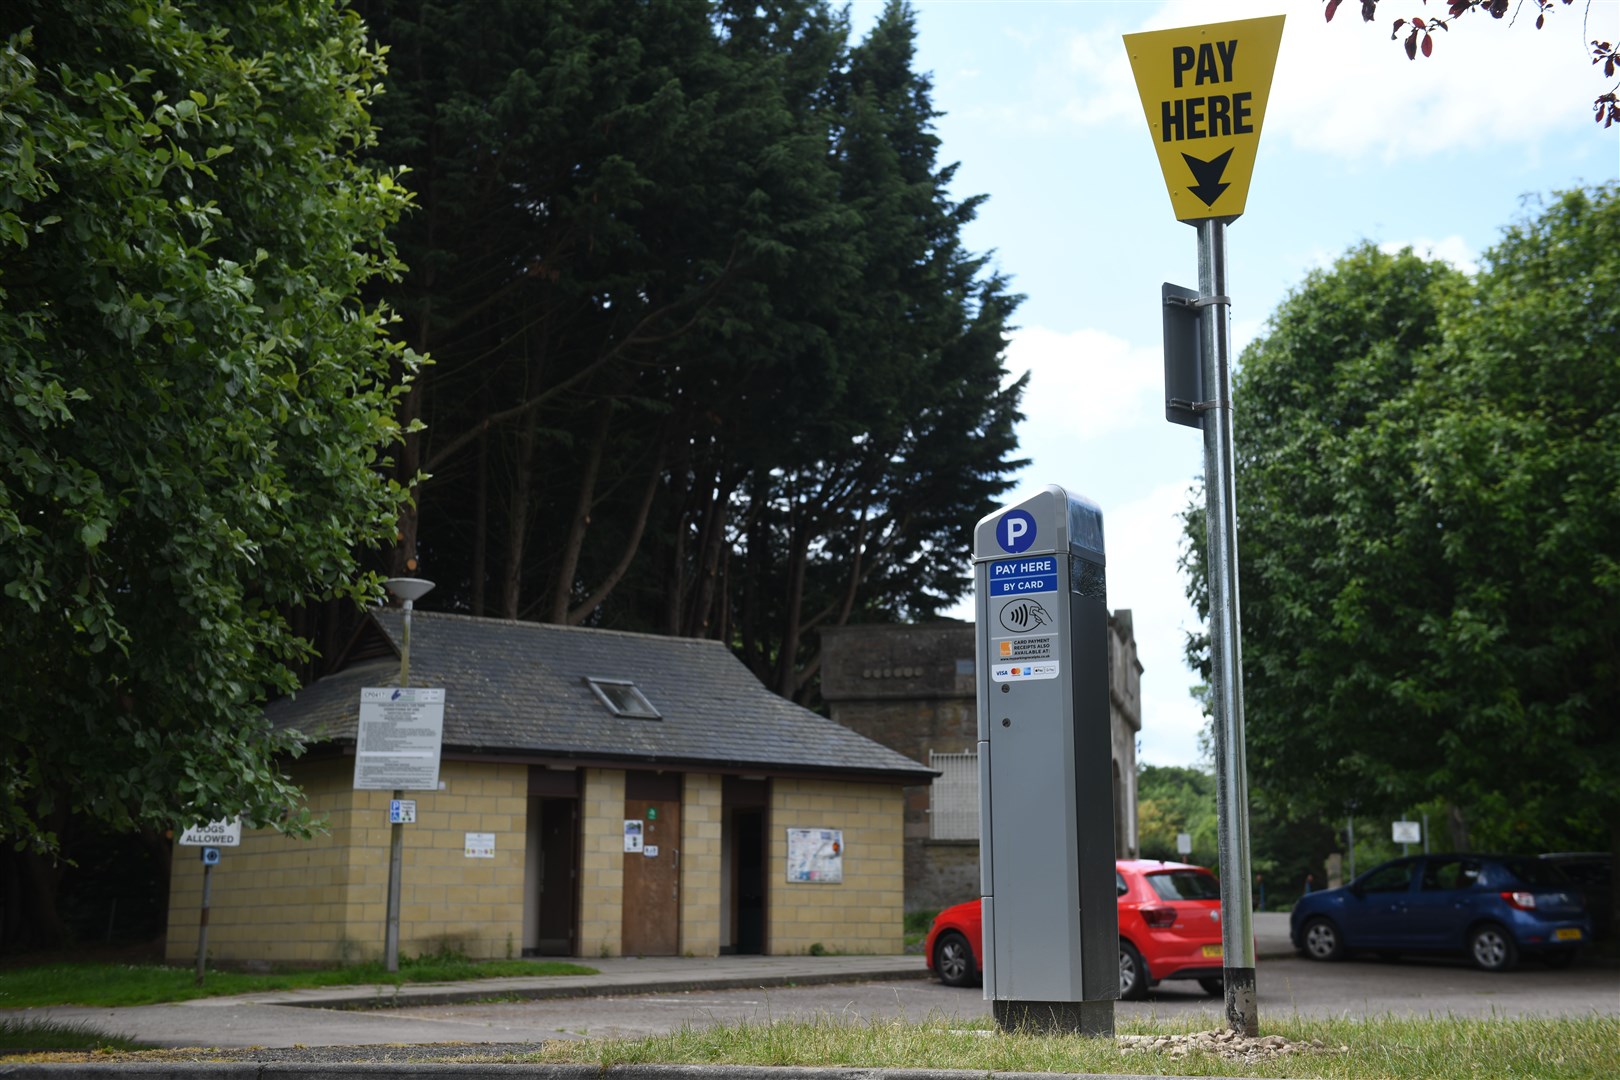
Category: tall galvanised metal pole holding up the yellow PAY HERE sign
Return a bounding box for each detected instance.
[1197,219,1260,1035]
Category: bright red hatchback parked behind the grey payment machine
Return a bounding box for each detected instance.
[927,860,1225,1001]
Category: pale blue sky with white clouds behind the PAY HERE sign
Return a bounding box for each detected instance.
[849,0,1620,766]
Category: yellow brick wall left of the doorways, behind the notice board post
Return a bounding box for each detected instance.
[165,758,528,963]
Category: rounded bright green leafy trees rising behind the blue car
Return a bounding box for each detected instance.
[1187,185,1620,893]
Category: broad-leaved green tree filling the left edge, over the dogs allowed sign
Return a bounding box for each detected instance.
[0,0,413,865]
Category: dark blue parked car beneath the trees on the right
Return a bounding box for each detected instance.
[1288,855,1592,972]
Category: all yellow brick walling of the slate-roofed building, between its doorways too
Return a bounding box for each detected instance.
[165,758,904,965]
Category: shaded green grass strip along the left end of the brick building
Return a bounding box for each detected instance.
[0,954,596,1009]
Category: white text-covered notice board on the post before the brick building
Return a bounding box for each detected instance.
[355,687,444,792]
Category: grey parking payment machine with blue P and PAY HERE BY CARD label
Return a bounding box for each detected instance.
[974,486,1119,1035]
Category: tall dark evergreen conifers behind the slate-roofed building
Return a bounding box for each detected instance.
[361,0,1021,699]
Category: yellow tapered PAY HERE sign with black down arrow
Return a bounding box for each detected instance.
[1124,15,1283,222]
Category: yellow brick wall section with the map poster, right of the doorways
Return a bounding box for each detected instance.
[766,779,906,955]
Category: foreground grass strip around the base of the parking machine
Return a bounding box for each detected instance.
[522,1017,1620,1080]
